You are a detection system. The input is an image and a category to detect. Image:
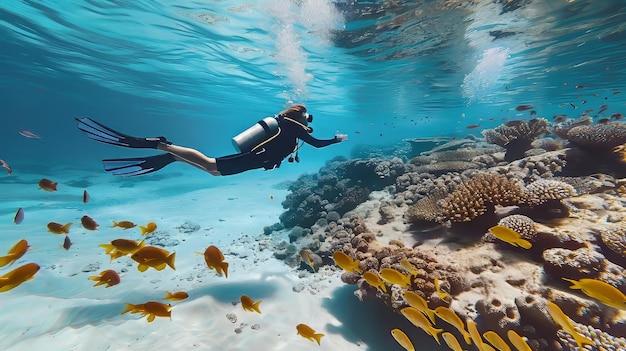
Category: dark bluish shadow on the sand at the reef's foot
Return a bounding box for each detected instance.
[322,285,448,351]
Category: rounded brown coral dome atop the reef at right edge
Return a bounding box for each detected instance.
[567,123,626,149]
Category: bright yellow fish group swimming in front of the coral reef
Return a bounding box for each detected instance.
[333,245,626,351]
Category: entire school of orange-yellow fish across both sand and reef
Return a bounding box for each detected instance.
[0,179,626,351]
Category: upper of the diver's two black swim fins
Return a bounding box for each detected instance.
[76,117,171,149]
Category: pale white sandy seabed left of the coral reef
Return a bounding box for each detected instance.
[0,166,445,351]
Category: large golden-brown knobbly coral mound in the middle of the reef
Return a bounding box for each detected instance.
[439,173,525,222]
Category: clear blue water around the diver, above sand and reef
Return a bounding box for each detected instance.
[0,0,626,350]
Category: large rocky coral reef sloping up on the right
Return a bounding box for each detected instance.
[272,124,626,351]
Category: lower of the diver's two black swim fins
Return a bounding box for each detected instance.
[102,153,176,177]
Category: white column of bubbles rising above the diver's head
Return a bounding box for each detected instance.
[268,0,343,100]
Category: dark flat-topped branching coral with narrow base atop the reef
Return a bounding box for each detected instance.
[482,118,548,161]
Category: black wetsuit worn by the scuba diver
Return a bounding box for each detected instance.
[215,117,339,175]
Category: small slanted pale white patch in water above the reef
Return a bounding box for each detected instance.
[462,47,509,102]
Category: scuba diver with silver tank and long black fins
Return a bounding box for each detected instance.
[76,104,348,176]
